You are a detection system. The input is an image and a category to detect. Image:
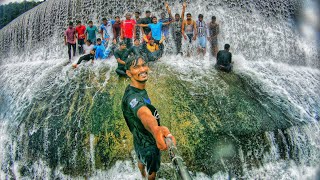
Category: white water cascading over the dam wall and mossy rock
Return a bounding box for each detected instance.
[0,0,320,179]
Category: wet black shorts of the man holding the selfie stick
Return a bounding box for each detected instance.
[135,146,161,175]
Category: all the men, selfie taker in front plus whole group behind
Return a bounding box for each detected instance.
[65,3,232,179]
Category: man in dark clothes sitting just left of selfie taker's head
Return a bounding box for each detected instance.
[114,41,128,77]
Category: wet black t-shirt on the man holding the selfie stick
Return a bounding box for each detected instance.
[122,85,160,149]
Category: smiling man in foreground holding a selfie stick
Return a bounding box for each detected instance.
[122,57,175,180]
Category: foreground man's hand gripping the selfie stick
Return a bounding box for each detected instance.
[153,126,176,151]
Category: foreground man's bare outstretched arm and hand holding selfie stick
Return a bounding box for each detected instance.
[137,106,175,150]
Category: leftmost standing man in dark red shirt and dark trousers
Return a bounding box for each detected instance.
[64,22,77,63]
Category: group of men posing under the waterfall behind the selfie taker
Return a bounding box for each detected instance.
[64,3,232,73]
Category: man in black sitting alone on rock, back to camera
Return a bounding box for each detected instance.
[215,44,232,72]
